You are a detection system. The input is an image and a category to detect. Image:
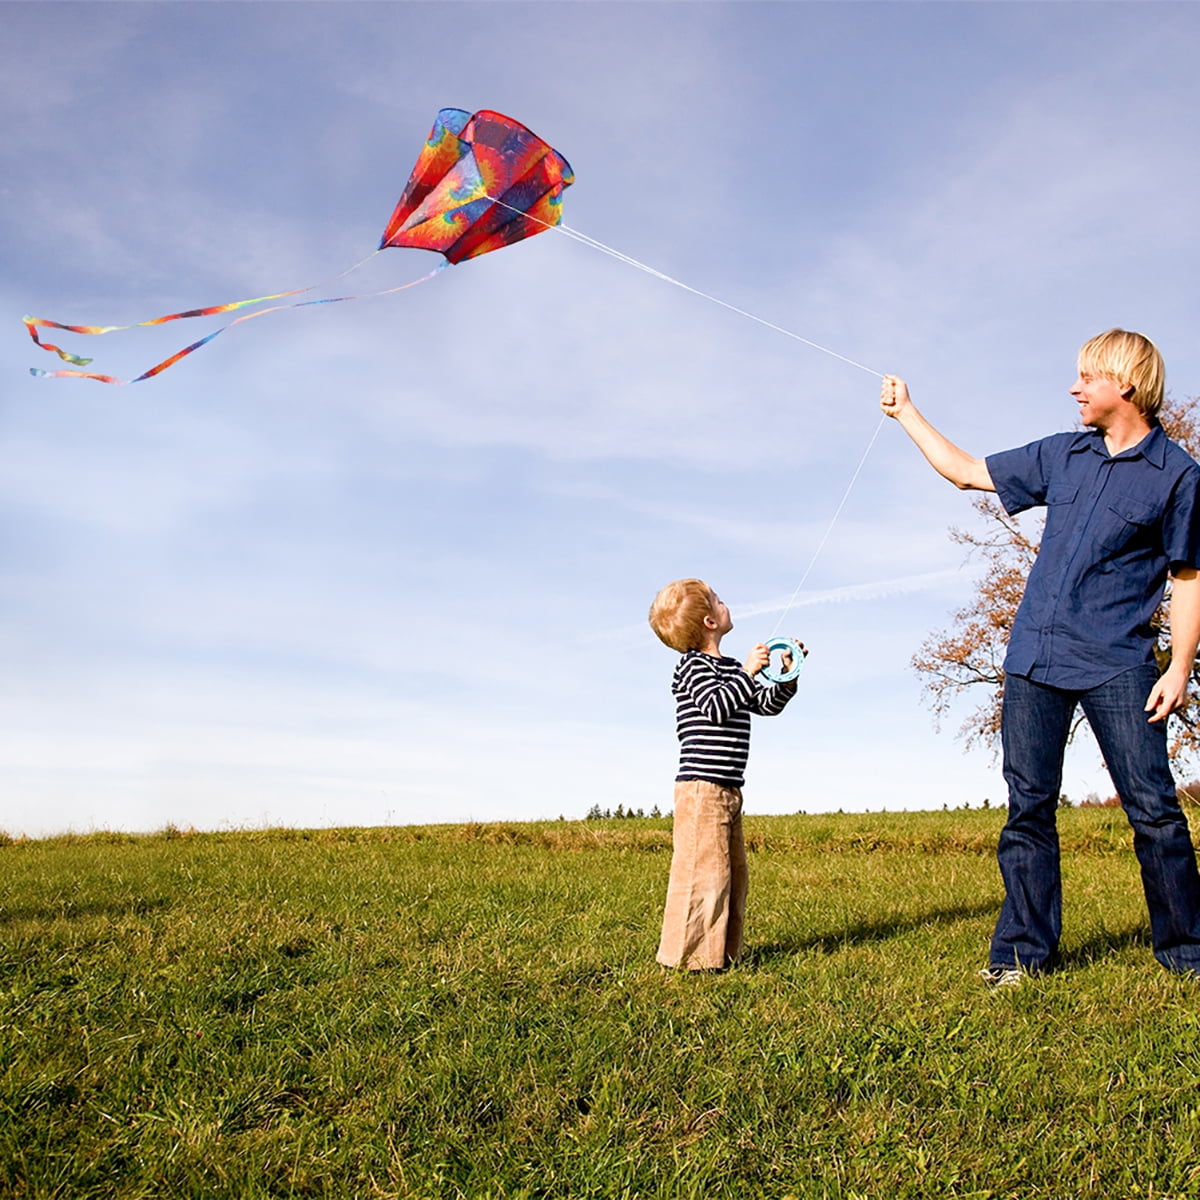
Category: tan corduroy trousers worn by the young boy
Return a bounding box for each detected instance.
[658,780,749,971]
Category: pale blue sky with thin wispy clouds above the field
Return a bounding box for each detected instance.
[0,0,1200,835]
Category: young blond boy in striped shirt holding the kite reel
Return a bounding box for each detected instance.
[650,580,803,971]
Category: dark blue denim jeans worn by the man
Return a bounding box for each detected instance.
[990,662,1200,973]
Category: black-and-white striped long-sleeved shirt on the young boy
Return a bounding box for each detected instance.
[671,650,796,787]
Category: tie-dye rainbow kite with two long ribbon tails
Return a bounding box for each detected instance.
[24,108,575,384]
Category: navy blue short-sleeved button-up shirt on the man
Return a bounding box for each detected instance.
[986,426,1200,690]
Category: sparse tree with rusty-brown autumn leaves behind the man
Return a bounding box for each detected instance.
[912,397,1200,764]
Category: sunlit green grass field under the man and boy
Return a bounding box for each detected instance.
[0,809,1200,1200]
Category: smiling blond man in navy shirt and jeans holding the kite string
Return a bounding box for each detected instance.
[881,329,1200,985]
